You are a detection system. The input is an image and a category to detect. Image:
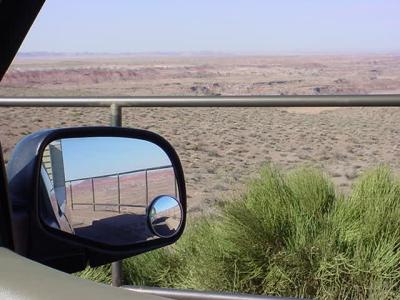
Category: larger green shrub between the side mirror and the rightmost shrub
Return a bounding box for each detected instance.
[173,167,335,296]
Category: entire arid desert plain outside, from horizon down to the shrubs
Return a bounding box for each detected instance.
[0,55,400,212]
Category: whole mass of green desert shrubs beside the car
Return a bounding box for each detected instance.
[80,166,400,299]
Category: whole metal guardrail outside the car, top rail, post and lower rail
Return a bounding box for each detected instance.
[0,94,400,300]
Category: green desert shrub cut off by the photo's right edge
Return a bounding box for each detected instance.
[317,167,400,299]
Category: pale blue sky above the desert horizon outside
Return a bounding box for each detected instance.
[20,0,400,54]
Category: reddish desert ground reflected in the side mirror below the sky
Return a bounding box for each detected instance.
[66,168,175,233]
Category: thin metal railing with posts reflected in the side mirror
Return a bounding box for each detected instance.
[65,165,178,213]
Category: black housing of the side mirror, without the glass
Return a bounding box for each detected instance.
[7,127,186,273]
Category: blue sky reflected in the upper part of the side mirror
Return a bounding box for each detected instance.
[61,137,171,181]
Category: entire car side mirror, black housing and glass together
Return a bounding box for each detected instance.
[8,127,186,272]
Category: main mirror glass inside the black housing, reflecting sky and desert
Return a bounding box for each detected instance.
[39,137,182,245]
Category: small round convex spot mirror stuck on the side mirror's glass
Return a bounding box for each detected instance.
[147,195,183,238]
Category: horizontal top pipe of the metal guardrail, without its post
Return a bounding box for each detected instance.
[0,94,400,107]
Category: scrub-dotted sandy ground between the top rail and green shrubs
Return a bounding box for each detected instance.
[0,108,400,211]
